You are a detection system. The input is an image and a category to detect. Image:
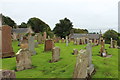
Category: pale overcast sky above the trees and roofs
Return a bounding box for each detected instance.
[0,0,119,32]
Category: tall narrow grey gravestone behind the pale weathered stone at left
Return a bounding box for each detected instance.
[28,36,36,55]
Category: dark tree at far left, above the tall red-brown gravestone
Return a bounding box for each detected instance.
[2,15,16,28]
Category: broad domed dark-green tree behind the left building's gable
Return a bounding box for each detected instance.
[27,17,51,33]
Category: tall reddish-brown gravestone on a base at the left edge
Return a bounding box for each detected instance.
[0,26,15,57]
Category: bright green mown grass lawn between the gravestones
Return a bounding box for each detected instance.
[2,41,118,78]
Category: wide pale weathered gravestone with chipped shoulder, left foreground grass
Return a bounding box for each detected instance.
[16,49,32,71]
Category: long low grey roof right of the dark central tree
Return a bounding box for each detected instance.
[70,33,100,39]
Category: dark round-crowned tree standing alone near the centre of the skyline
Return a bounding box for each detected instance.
[53,18,73,38]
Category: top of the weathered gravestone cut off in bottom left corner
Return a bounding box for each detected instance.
[0,69,16,80]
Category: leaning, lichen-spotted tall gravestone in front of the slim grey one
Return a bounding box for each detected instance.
[73,50,88,80]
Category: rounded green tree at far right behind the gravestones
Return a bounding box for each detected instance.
[103,30,118,43]
